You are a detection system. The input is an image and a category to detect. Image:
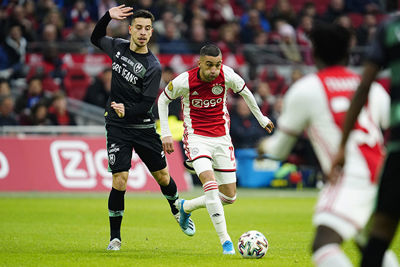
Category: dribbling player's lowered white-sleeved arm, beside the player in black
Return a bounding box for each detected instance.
[157,82,174,154]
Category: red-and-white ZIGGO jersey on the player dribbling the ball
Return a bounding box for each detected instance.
[164,65,245,137]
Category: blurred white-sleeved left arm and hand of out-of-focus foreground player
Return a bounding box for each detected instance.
[257,82,310,160]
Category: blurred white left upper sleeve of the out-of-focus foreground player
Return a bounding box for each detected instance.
[278,82,313,135]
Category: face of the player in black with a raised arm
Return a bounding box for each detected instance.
[129,18,153,47]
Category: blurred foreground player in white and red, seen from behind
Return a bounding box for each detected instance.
[259,24,398,267]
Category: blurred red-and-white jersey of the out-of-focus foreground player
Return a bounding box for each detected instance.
[267,66,390,181]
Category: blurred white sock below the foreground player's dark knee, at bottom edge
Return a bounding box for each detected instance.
[312,243,353,267]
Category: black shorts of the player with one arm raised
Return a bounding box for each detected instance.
[106,125,167,173]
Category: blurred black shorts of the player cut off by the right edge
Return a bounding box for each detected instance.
[376,151,400,218]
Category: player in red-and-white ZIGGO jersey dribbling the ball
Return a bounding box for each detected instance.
[158,44,274,254]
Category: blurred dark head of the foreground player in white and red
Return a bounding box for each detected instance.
[310,22,351,66]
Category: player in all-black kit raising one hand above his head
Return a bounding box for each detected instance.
[91,5,194,250]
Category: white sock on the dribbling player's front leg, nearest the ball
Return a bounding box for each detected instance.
[203,181,231,244]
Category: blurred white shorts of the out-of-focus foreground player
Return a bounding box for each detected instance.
[313,177,377,240]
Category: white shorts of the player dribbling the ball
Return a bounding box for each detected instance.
[183,134,236,185]
